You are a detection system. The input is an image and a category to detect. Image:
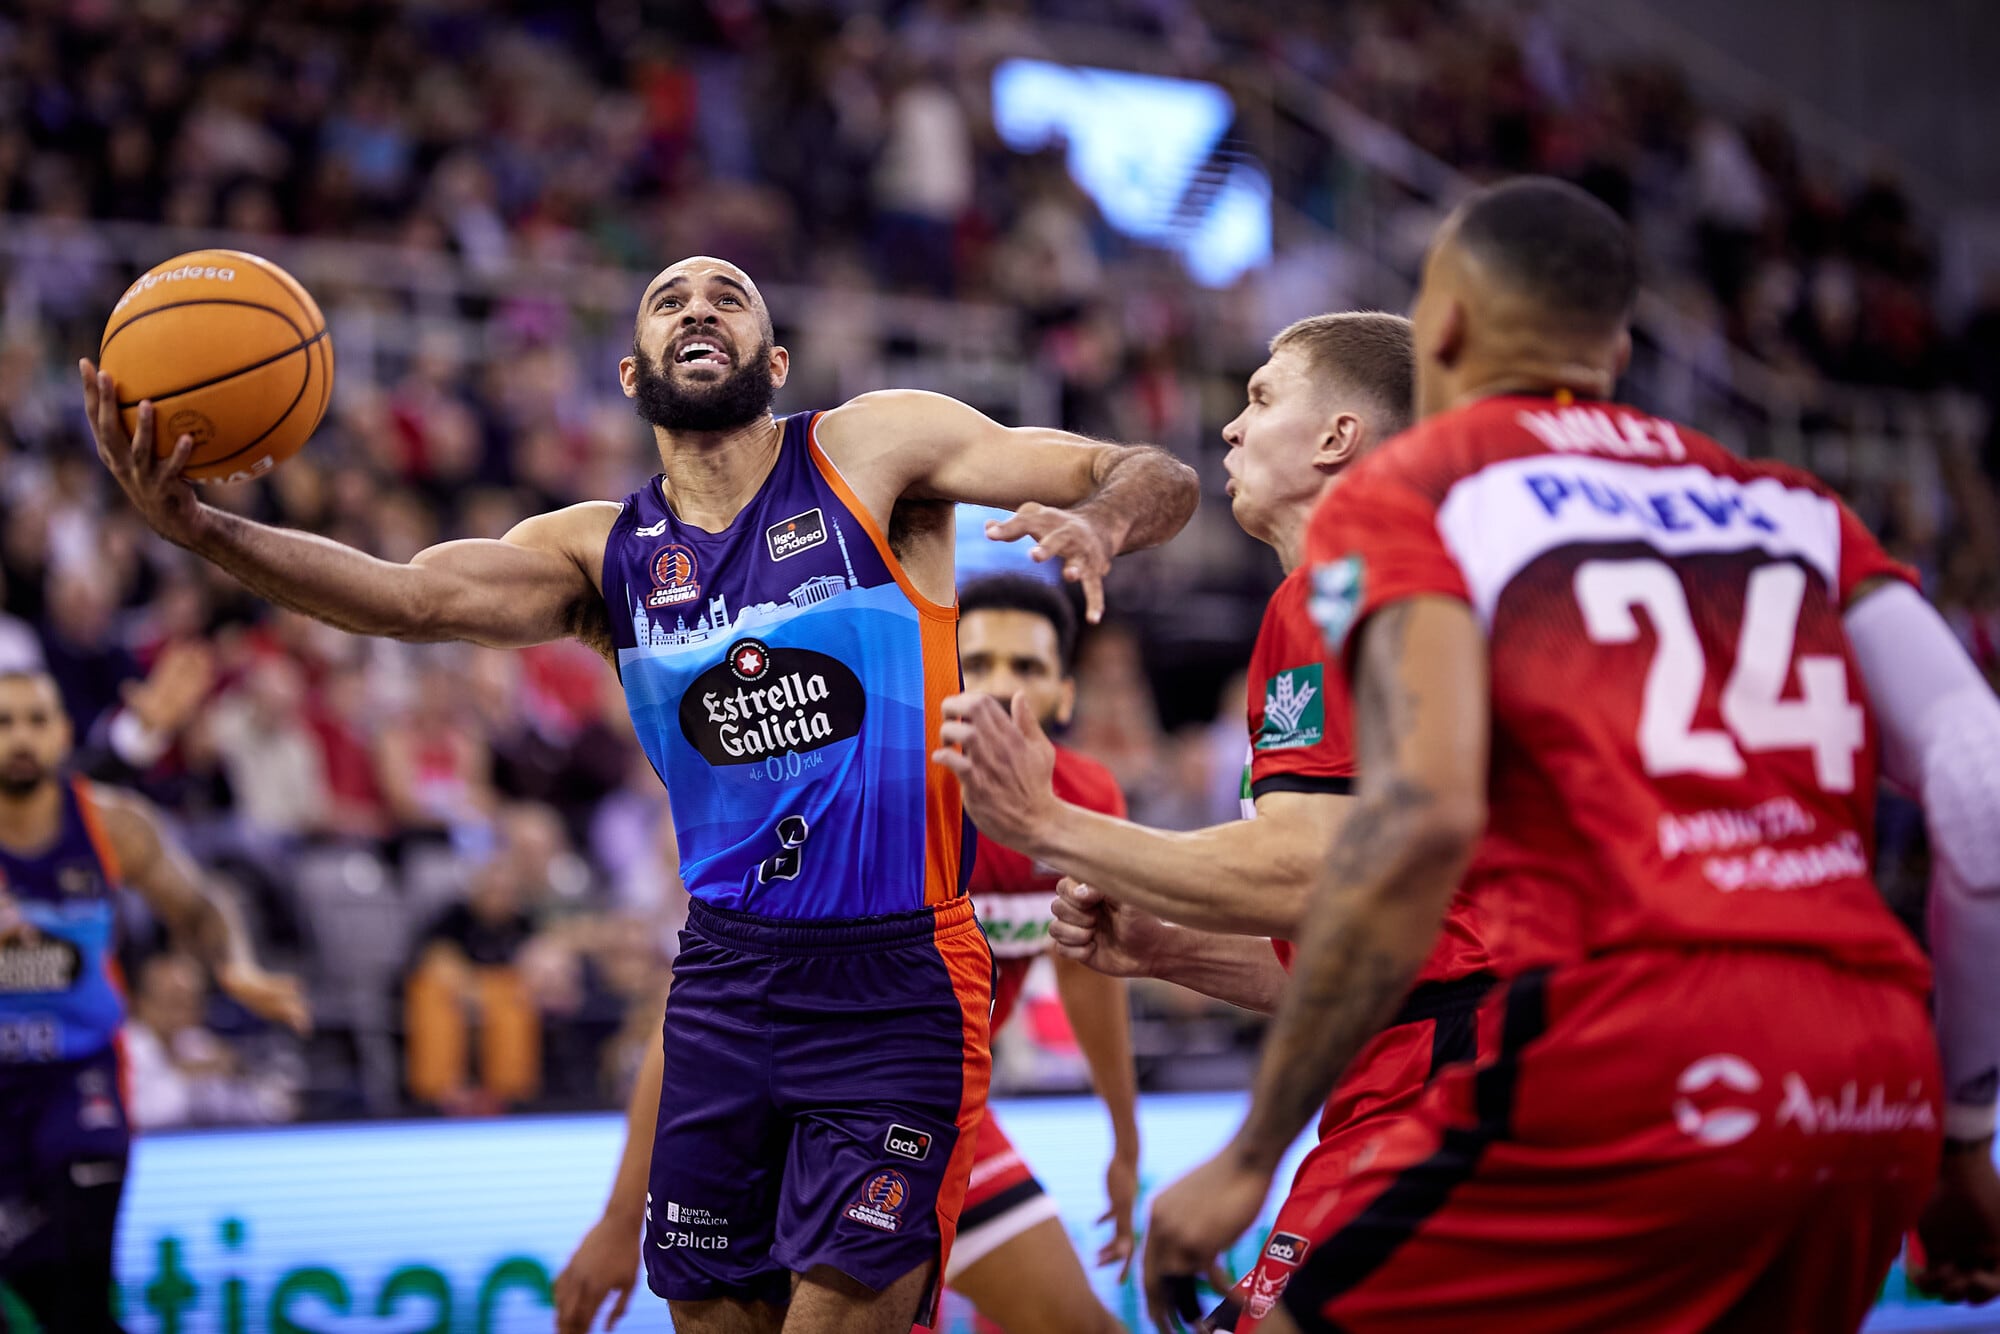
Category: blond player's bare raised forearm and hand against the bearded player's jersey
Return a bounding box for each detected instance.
[932,694,1354,940]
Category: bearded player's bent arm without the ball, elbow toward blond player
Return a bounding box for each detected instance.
[818,390,1200,622]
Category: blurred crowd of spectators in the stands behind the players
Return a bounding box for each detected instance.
[0,0,2000,1124]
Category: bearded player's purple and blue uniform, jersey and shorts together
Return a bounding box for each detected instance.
[604,414,992,1302]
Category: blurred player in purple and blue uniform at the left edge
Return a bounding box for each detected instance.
[0,672,308,1334]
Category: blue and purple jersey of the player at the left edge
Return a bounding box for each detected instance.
[0,780,124,1066]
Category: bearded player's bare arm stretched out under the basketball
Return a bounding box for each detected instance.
[82,362,618,648]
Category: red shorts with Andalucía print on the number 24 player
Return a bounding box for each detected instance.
[1282,950,1940,1334]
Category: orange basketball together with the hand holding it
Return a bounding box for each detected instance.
[78,250,334,546]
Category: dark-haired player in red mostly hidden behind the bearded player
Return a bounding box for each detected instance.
[556,574,1138,1334]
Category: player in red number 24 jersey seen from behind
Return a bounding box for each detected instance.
[1148,180,2000,1334]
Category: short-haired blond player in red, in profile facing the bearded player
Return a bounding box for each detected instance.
[948,312,1492,1334]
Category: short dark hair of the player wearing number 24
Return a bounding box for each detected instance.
[1456,176,1638,334]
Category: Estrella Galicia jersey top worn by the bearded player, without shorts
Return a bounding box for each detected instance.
[604,412,964,920]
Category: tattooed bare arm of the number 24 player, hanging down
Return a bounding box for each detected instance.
[1146,596,1490,1328]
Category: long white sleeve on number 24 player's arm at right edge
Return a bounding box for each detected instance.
[1846,584,2000,1140]
